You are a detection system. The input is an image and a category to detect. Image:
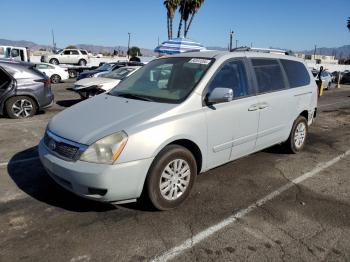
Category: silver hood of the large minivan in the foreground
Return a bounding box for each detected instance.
[48,94,177,145]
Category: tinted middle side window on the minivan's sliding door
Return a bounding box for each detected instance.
[252,59,286,94]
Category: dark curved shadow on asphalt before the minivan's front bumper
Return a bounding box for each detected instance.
[7,147,116,212]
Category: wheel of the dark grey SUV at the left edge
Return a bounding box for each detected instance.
[5,96,38,119]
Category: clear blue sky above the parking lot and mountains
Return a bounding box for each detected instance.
[0,0,350,51]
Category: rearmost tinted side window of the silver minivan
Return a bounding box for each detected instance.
[280,59,310,88]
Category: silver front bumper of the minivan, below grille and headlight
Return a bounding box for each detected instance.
[39,140,153,202]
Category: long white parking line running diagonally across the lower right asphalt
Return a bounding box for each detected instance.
[151,150,350,262]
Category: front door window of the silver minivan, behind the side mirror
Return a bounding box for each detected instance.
[208,60,253,98]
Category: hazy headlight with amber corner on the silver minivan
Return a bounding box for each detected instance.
[80,131,128,164]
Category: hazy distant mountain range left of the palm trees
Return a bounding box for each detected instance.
[0,39,155,56]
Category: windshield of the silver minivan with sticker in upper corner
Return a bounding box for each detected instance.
[109,57,213,103]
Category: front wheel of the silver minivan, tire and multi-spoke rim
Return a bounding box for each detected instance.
[145,145,197,210]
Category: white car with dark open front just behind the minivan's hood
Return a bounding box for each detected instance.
[72,66,141,99]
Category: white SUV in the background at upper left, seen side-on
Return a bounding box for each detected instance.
[40,49,90,66]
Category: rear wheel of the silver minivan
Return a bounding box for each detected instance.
[285,116,308,154]
